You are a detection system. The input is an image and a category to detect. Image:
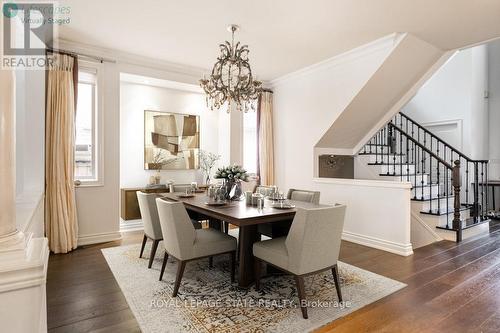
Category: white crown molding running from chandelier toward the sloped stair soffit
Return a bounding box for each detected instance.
[269,33,406,88]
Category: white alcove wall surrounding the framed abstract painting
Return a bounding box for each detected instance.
[120,81,220,187]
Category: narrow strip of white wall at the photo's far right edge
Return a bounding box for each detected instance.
[488,40,500,180]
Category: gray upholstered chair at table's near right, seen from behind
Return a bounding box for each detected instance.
[253,205,346,319]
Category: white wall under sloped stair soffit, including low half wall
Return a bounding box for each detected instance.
[273,37,411,255]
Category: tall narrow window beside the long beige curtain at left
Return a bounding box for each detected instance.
[75,67,100,185]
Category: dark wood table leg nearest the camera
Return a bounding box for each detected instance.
[238,225,259,288]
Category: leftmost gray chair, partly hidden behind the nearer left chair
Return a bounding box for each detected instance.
[137,191,163,268]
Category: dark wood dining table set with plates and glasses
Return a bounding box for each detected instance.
[160,193,325,288]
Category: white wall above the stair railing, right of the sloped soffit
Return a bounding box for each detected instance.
[402,45,489,159]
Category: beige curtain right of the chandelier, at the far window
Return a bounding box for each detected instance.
[258,91,275,185]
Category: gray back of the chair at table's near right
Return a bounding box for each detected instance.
[285,205,346,274]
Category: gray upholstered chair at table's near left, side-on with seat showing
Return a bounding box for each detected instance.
[156,198,236,297]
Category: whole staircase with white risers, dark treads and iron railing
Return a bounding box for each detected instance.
[357,113,489,247]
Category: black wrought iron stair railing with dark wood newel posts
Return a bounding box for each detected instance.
[361,113,488,241]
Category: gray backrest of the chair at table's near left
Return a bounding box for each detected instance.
[156,198,196,260]
